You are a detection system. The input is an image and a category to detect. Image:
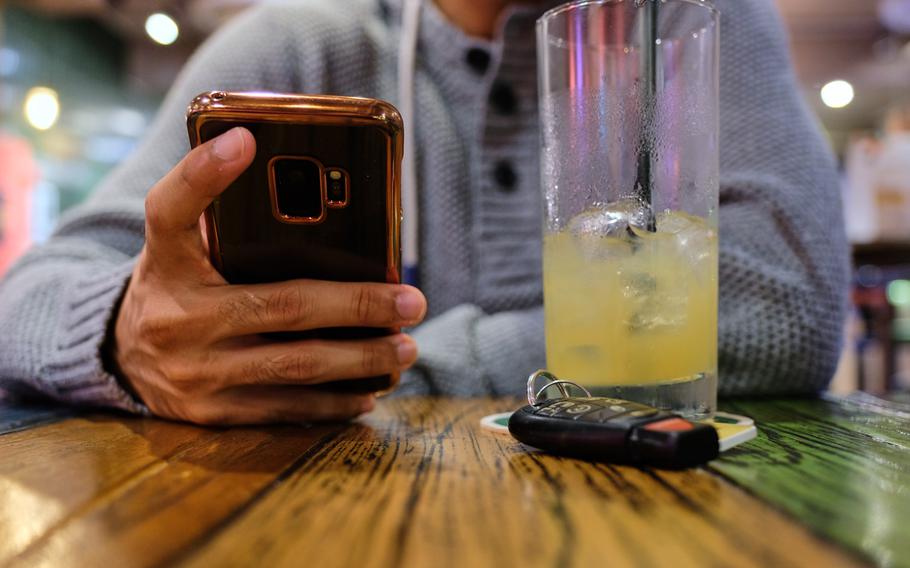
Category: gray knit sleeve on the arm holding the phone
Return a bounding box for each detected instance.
[0,6,306,412]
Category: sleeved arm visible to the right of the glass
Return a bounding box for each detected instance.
[718,0,849,394]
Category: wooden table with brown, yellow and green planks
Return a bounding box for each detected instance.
[0,397,910,568]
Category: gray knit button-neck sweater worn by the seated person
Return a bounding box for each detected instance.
[0,0,848,410]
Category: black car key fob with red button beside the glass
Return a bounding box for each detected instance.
[509,397,719,469]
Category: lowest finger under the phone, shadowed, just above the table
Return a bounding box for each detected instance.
[189,387,376,425]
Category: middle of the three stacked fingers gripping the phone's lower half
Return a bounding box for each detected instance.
[212,334,417,388]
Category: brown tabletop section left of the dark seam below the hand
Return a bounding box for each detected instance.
[0,416,342,568]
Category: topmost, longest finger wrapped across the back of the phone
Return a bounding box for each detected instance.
[210,280,427,338]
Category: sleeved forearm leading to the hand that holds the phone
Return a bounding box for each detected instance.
[0,240,143,412]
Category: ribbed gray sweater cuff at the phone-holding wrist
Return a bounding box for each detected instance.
[41,260,149,414]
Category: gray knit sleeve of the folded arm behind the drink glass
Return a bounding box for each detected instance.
[405,0,848,395]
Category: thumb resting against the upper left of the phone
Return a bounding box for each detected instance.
[146,128,256,258]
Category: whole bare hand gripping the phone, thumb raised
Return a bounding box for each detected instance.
[110,128,426,424]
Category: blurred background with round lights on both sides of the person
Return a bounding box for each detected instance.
[0,0,910,392]
